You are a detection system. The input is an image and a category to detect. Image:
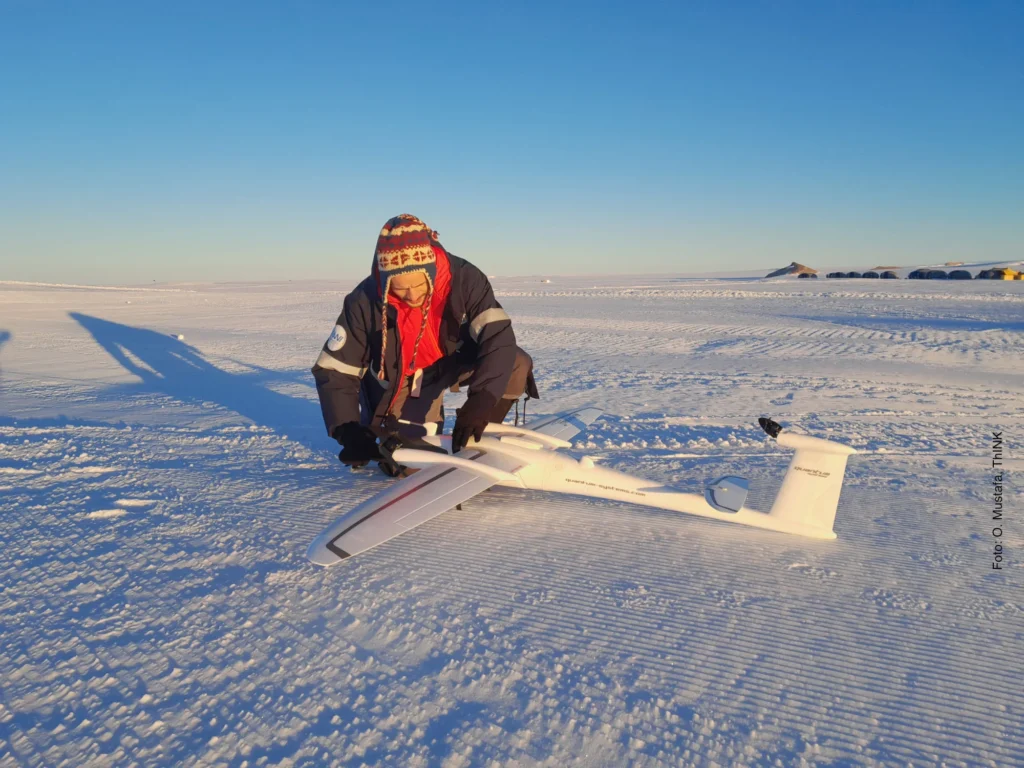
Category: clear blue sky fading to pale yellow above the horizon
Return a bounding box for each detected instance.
[0,0,1024,283]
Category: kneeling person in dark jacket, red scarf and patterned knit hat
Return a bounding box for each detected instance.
[312,214,538,473]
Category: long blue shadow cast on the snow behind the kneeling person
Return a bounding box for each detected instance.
[70,312,326,447]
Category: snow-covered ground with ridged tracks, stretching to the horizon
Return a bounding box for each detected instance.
[0,276,1024,768]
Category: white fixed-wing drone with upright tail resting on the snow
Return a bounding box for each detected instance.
[307,408,857,565]
